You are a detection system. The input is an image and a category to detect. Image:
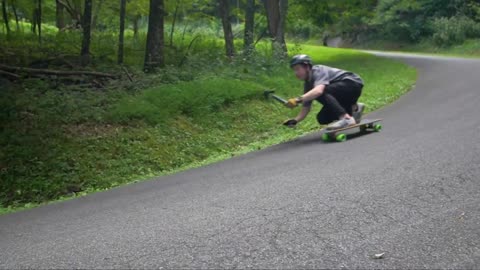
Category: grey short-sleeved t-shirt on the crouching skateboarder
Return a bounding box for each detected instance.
[303,65,363,107]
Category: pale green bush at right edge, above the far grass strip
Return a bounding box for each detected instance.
[430,16,480,46]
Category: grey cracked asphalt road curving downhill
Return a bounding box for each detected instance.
[0,52,480,269]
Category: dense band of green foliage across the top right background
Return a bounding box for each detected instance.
[287,0,480,44]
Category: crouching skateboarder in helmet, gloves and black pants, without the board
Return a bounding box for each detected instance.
[283,54,365,130]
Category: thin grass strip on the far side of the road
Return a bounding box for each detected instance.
[356,39,480,58]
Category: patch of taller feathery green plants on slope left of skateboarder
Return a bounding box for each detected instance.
[112,78,262,124]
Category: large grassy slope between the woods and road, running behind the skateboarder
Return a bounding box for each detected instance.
[0,45,416,213]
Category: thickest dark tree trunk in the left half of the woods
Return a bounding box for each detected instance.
[144,0,165,72]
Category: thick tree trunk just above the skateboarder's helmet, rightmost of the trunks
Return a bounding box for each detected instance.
[264,0,288,58]
